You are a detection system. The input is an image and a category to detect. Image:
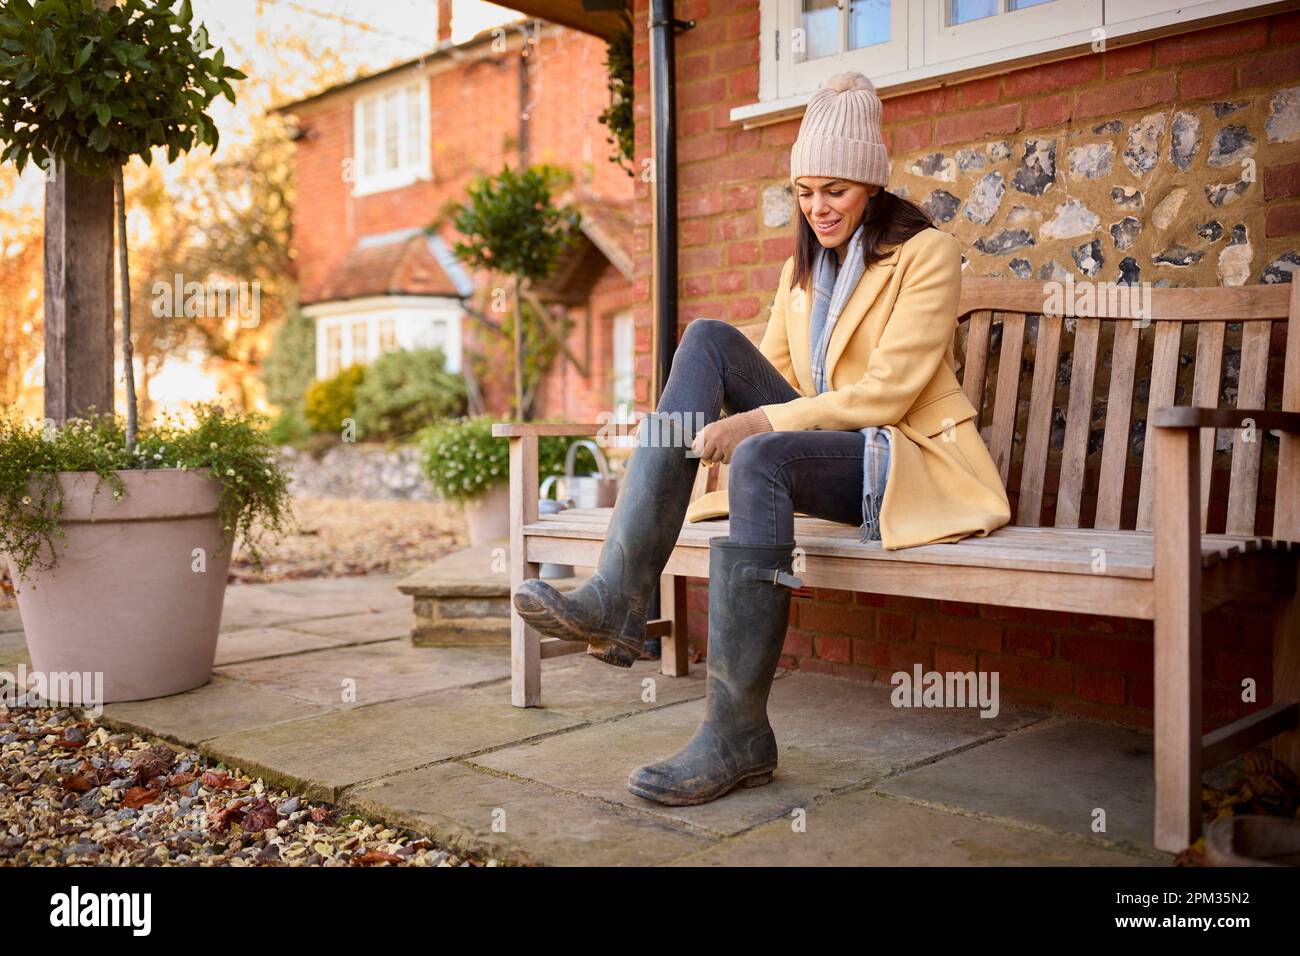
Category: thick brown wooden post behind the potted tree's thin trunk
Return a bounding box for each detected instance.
[46,164,113,423]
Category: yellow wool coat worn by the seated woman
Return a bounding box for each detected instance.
[688,229,1011,550]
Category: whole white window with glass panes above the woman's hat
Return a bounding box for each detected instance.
[748,0,1269,121]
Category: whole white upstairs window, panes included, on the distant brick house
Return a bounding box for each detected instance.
[352,77,430,195]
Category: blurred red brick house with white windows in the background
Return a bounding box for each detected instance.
[278,0,633,419]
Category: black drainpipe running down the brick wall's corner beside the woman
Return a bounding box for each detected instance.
[646,0,696,642]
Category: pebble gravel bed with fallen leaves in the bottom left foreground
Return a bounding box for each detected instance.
[0,708,499,866]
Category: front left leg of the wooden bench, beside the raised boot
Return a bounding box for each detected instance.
[510,434,542,708]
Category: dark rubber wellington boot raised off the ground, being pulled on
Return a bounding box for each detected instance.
[514,412,699,667]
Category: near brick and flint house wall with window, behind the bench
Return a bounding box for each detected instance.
[504,0,1300,728]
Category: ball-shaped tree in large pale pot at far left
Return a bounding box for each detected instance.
[0,0,279,701]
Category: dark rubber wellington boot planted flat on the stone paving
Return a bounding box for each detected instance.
[628,537,802,806]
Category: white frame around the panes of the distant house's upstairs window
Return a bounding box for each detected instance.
[352,73,433,196]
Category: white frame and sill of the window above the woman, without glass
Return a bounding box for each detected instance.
[731,0,1274,127]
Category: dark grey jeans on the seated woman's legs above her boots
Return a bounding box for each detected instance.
[655,319,866,544]
